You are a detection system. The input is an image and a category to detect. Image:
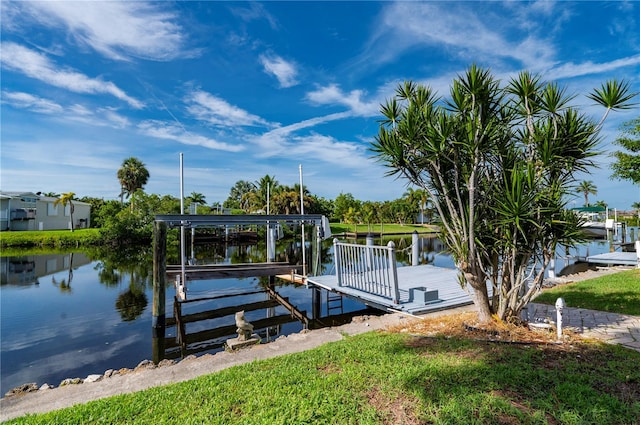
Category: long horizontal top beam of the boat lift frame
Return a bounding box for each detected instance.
[155,214,323,228]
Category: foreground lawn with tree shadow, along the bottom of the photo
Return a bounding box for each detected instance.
[14,332,640,425]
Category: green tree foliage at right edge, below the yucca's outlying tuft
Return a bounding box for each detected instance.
[611,118,640,185]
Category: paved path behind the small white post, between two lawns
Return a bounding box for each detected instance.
[528,303,640,351]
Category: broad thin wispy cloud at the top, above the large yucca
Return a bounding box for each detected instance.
[359,2,555,71]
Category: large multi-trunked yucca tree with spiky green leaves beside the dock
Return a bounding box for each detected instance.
[372,65,635,322]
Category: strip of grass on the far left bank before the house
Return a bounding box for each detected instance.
[0,228,101,250]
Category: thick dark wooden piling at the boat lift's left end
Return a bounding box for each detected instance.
[151,221,167,345]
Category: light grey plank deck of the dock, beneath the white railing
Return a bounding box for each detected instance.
[306,265,480,314]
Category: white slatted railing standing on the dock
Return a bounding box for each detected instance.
[333,239,400,304]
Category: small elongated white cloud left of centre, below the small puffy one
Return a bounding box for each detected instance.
[185,90,270,127]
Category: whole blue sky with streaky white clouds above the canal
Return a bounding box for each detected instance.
[0,1,640,209]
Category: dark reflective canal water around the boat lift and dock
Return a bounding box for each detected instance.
[0,229,632,395]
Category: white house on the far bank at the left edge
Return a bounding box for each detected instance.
[0,191,91,231]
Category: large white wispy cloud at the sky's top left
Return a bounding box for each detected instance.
[14,1,192,61]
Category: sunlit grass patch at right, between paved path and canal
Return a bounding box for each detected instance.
[534,269,640,316]
